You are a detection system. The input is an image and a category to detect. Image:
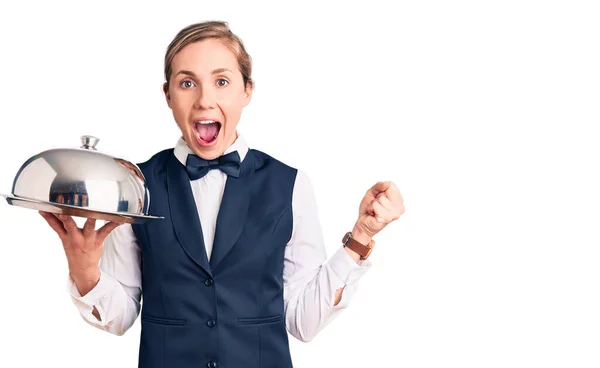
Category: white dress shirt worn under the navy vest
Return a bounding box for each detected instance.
[68,136,371,342]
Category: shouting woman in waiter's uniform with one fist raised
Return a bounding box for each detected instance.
[37,22,404,368]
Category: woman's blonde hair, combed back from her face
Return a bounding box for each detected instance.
[165,21,254,89]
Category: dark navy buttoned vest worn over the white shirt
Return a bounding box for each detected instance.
[133,149,297,368]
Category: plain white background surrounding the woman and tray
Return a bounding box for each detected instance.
[0,1,600,368]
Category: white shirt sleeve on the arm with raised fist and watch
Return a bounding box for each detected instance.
[283,170,371,342]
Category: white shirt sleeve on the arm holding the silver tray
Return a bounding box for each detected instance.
[67,224,141,335]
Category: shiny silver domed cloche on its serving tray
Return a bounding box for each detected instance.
[0,136,162,223]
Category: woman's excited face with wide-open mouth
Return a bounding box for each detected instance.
[164,39,252,160]
